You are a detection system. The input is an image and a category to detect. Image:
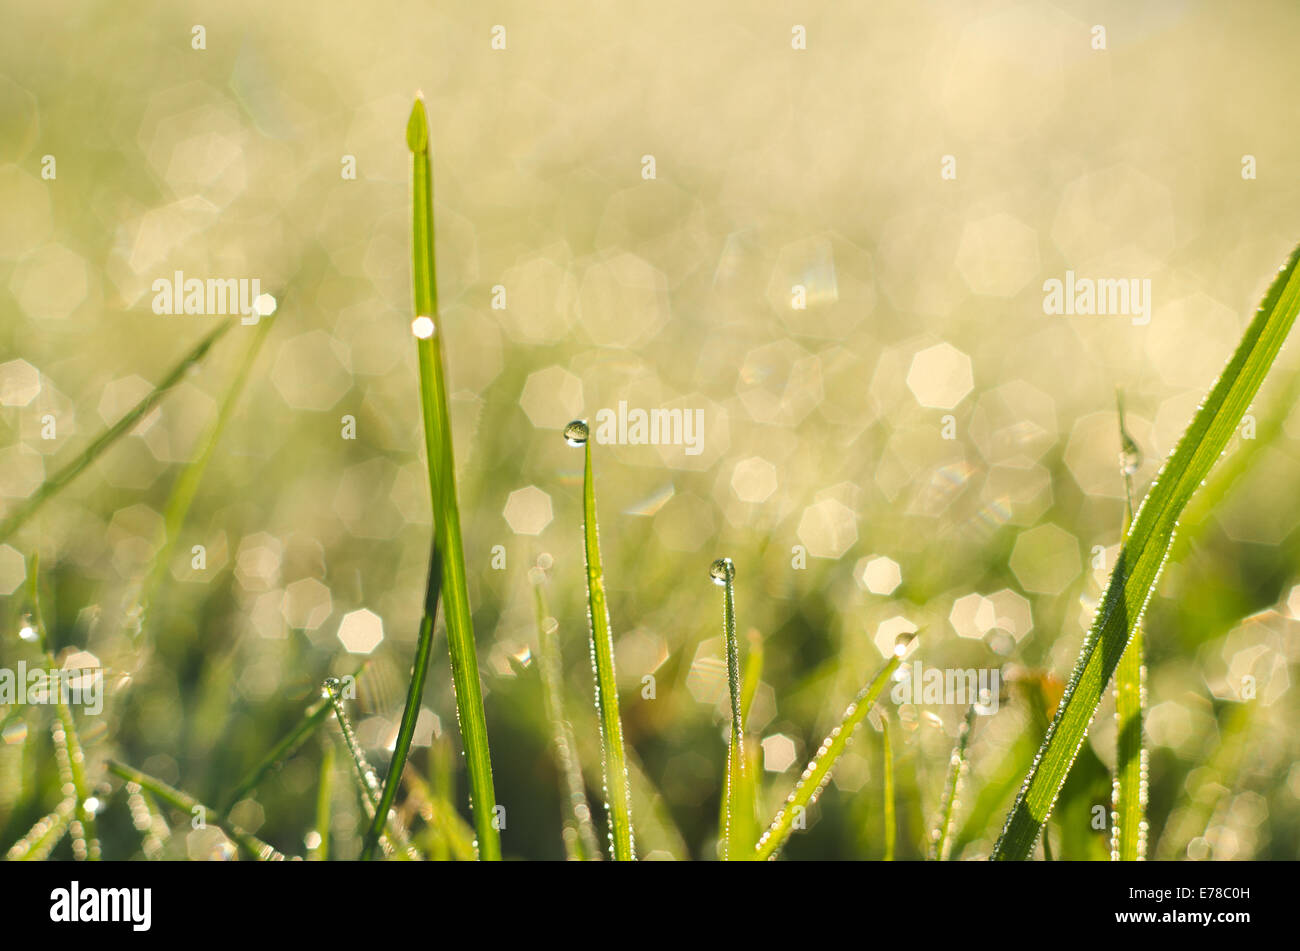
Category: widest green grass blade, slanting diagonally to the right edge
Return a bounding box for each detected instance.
[991,242,1300,859]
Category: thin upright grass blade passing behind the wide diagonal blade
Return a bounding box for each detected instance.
[1110,391,1147,861]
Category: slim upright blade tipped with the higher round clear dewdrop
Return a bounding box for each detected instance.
[564,420,637,861]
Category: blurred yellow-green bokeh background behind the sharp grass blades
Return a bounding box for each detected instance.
[0,0,1300,859]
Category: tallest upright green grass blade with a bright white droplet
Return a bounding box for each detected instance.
[407,99,501,861]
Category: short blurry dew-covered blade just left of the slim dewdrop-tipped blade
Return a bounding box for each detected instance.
[529,556,601,861]
